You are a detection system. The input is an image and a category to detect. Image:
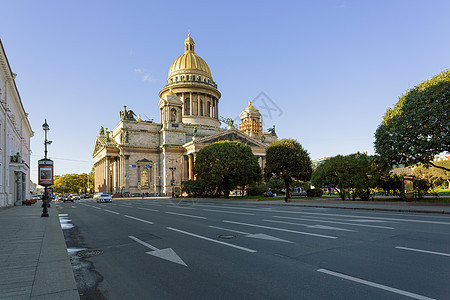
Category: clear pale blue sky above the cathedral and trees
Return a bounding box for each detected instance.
[0,0,450,182]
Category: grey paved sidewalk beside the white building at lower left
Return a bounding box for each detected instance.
[0,201,80,299]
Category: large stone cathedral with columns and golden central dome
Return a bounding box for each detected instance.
[92,34,277,195]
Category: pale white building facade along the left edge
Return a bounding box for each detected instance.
[0,40,34,207]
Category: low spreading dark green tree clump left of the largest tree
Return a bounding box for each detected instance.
[311,153,378,200]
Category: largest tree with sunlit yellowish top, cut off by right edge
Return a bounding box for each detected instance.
[375,70,450,171]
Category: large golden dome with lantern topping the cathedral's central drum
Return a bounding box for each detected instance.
[167,34,212,80]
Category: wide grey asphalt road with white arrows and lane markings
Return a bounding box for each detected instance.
[57,198,450,299]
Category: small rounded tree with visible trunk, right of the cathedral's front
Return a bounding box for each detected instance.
[264,139,312,202]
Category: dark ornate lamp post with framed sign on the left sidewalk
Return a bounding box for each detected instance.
[38,119,53,217]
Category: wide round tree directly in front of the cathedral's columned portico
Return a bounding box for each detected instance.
[194,141,261,198]
